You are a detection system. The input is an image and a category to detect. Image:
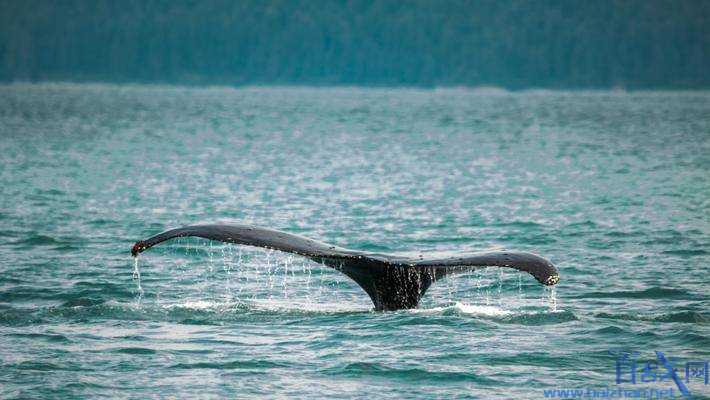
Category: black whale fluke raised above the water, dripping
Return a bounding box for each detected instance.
[131,225,560,310]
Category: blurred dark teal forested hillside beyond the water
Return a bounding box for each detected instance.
[0,0,710,89]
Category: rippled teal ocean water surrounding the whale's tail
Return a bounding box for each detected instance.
[0,84,710,399]
